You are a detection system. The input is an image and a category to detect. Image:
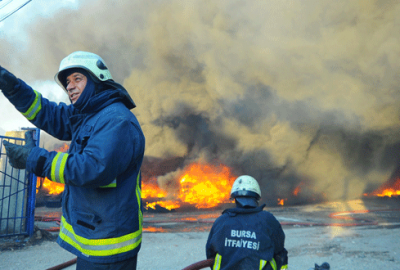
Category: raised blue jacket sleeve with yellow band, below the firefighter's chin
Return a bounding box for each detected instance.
[5,79,73,140]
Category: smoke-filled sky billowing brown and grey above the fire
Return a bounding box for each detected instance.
[0,0,400,202]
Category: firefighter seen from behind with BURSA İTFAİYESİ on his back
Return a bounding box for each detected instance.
[206,175,288,270]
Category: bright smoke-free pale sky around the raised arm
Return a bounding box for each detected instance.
[0,0,78,135]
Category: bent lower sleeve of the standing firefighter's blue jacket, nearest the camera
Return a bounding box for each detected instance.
[27,114,144,188]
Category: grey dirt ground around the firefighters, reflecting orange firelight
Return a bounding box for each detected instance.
[0,198,400,270]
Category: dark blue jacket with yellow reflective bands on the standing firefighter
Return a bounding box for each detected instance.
[7,80,145,263]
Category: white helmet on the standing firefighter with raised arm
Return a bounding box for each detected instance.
[54,51,113,90]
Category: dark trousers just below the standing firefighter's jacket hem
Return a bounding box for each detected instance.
[76,255,137,270]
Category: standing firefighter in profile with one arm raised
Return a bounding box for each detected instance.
[0,51,145,270]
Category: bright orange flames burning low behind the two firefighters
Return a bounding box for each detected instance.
[37,148,400,209]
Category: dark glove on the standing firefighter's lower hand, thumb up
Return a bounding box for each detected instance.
[3,131,36,169]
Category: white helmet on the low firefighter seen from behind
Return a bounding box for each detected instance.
[231,175,261,200]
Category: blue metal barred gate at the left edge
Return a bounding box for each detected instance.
[0,128,40,237]
